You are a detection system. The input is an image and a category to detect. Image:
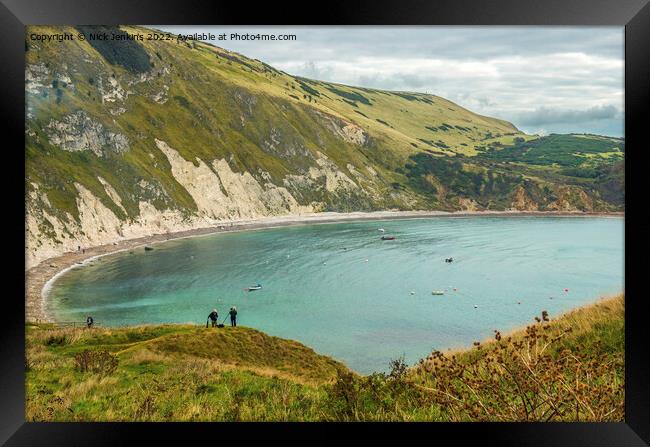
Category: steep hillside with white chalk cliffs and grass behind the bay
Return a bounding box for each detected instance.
[25,27,619,267]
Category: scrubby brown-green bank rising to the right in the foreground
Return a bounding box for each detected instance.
[328,297,624,422]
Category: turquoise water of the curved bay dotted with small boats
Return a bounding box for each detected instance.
[48,217,624,373]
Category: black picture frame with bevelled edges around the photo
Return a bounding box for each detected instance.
[0,0,650,446]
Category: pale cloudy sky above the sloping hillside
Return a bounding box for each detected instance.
[157,25,624,136]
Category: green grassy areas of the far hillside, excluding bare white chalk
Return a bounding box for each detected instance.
[26,27,622,235]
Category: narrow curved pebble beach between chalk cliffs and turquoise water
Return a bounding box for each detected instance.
[25,211,625,322]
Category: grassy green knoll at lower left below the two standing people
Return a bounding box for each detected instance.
[27,325,345,421]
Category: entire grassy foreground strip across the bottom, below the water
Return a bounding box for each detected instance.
[25,296,624,421]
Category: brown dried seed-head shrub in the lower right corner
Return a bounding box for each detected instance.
[420,312,624,421]
